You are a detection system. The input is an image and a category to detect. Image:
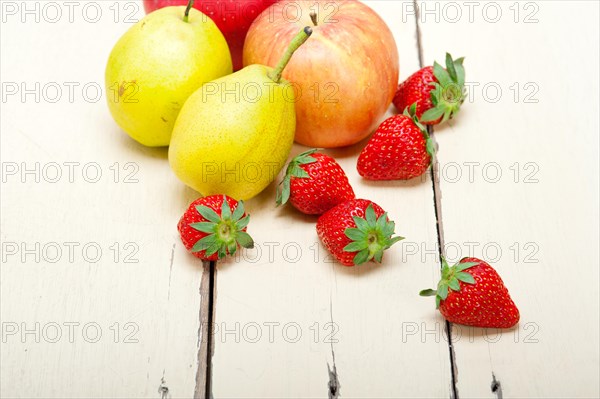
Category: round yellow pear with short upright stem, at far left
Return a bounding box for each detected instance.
[105,0,232,147]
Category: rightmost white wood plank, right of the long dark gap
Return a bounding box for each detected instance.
[421,1,600,398]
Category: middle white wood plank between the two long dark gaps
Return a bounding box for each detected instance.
[213,1,450,398]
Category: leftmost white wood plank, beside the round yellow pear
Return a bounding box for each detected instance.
[0,1,202,398]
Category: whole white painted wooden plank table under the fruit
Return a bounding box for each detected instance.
[0,0,600,398]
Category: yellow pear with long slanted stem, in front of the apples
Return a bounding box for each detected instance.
[169,27,312,200]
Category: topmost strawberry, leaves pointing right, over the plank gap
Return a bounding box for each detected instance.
[394,53,465,125]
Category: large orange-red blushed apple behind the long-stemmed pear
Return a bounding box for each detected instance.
[244,0,399,148]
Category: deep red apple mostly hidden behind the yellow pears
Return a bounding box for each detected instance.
[144,0,277,71]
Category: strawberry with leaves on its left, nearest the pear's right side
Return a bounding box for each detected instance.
[277,150,355,215]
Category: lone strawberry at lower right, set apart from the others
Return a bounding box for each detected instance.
[420,258,519,328]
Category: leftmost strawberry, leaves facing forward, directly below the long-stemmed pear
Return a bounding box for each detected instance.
[177,195,254,261]
